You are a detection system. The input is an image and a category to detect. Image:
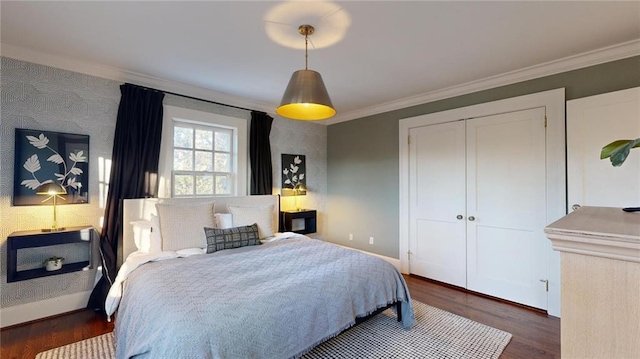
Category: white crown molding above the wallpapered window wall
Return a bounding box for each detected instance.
[0,44,276,114]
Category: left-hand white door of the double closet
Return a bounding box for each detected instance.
[409,121,466,287]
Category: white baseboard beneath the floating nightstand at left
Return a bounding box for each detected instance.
[0,291,91,328]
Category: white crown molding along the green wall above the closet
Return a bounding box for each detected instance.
[322,39,640,125]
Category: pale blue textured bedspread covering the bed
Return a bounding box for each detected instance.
[115,237,415,359]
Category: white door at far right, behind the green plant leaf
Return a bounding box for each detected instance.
[567,88,640,212]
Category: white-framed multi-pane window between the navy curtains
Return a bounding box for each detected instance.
[159,106,247,197]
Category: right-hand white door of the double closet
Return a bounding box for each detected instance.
[466,108,547,309]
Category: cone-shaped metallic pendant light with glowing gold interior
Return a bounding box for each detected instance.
[276,25,336,120]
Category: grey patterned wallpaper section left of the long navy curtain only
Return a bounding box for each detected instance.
[0,57,120,308]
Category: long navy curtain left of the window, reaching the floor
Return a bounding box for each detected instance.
[87,84,164,311]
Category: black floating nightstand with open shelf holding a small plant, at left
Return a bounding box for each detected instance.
[7,226,98,282]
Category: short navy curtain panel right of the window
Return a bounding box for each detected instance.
[249,111,273,195]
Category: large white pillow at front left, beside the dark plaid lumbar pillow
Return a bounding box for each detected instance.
[156,202,215,251]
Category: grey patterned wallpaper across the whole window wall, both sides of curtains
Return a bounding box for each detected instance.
[0,57,327,308]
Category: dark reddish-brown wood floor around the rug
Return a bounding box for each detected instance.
[0,276,560,359]
